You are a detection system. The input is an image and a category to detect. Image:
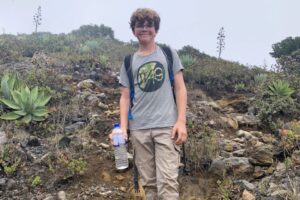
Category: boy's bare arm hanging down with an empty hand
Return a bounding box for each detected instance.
[172,71,187,144]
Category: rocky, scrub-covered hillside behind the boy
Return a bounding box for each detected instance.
[0,26,300,200]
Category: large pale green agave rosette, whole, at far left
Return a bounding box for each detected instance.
[0,86,51,123]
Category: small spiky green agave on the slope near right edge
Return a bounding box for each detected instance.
[268,80,294,97]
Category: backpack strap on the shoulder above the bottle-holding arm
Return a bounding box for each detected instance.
[124,54,134,120]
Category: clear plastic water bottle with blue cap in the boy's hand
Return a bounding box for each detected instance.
[112,123,128,170]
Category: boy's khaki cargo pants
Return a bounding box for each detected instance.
[131,127,180,200]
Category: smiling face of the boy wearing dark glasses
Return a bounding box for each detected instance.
[133,21,156,44]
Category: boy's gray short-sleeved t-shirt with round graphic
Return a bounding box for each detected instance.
[120,46,183,130]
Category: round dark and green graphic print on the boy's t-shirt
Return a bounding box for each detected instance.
[137,61,165,92]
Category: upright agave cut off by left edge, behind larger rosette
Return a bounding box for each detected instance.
[0,73,22,100]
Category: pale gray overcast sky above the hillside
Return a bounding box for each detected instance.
[0,0,300,66]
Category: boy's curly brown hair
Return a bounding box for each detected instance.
[130,8,160,32]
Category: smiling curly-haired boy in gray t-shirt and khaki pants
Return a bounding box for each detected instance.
[120,8,187,200]
